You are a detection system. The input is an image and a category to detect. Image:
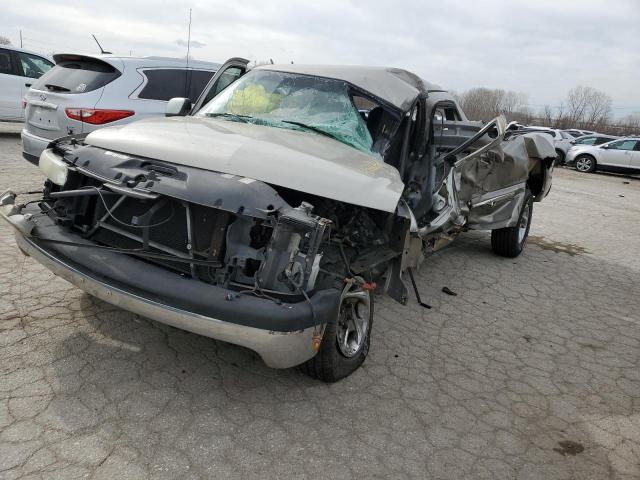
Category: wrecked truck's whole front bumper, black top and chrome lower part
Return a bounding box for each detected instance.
[0,191,340,368]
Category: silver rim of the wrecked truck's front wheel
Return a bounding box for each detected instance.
[336,290,371,358]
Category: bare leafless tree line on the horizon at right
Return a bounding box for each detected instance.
[454,85,640,135]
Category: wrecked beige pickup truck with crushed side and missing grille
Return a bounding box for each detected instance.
[0,59,556,381]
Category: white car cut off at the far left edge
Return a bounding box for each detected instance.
[0,45,53,122]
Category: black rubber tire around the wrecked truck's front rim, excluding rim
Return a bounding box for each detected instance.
[298,291,373,383]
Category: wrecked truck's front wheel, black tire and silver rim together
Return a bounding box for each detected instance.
[299,286,373,382]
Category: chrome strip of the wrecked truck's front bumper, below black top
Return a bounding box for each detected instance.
[0,192,324,368]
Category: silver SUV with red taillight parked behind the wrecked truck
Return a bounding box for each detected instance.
[22,54,220,164]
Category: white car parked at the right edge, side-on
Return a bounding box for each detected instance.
[567,137,640,173]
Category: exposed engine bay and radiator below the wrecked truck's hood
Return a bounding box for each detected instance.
[32,140,409,301]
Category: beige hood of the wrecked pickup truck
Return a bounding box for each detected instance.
[85,117,404,212]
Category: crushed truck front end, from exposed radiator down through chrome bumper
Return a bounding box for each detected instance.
[0,139,341,368]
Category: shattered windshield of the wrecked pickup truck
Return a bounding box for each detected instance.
[197,70,373,153]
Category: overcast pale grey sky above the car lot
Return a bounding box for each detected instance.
[0,0,640,116]
